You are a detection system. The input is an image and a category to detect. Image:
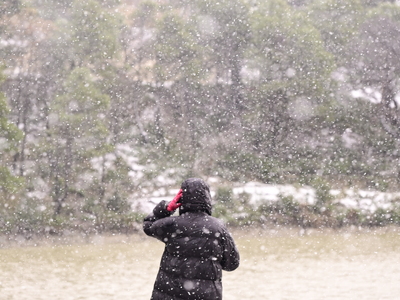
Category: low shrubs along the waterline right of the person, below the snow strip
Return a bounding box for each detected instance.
[214,191,400,228]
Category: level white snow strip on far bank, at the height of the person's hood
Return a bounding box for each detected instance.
[132,182,400,213]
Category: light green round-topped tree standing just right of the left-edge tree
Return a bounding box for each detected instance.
[48,68,113,214]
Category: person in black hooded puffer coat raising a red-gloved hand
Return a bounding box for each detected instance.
[143,178,239,300]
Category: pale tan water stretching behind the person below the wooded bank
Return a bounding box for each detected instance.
[0,228,400,300]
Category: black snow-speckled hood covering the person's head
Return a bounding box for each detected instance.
[179,178,212,216]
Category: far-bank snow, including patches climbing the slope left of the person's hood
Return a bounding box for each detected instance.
[92,144,400,213]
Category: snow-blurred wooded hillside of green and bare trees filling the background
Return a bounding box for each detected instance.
[0,0,400,237]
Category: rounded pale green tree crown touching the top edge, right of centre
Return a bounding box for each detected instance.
[250,0,333,97]
